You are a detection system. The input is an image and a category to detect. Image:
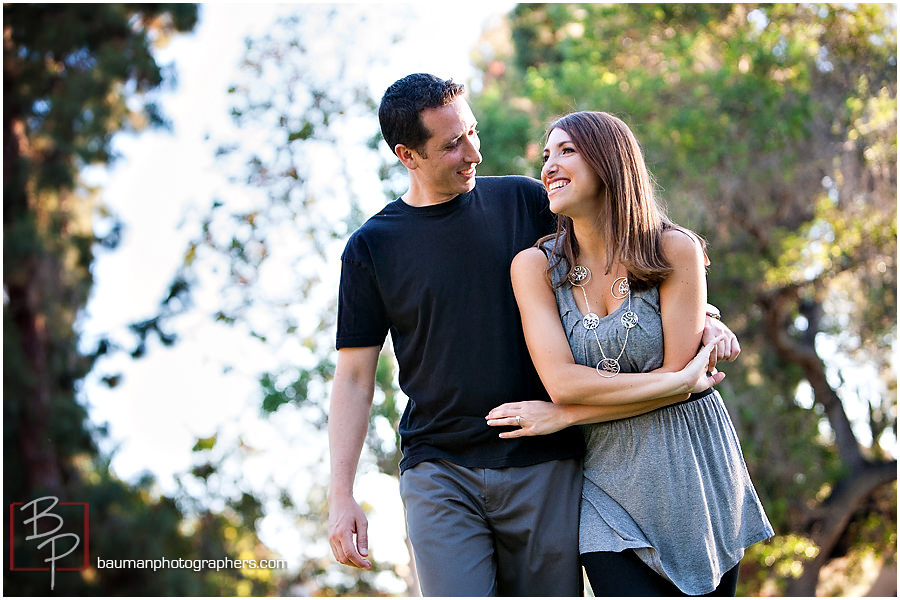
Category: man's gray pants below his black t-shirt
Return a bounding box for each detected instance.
[400,459,583,596]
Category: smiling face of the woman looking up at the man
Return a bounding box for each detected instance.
[541,128,603,218]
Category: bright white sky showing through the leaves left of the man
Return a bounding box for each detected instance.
[78,2,513,580]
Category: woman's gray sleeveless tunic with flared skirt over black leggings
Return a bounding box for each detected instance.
[544,242,774,595]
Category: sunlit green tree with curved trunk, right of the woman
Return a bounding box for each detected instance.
[474,4,897,596]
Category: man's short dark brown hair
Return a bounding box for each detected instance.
[378,73,466,152]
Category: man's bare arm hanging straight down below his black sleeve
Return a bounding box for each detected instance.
[328,346,380,569]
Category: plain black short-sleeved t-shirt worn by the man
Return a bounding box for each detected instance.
[336,176,583,470]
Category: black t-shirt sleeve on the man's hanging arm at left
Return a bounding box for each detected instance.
[335,233,390,350]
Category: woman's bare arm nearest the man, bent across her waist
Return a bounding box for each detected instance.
[511,248,716,414]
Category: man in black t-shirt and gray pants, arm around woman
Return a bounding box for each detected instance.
[329,74,739,596]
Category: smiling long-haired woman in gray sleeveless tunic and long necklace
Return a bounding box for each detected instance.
[488,112,774,596]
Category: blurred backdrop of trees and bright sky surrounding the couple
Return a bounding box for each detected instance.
[3,2,897,596]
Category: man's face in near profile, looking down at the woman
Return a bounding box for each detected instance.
[417,97,481,200]
